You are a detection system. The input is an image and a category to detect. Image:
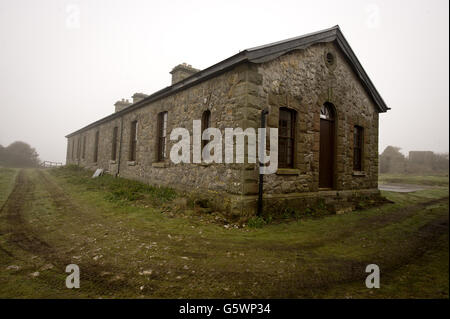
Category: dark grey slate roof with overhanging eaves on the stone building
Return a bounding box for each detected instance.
[66,25,390,137]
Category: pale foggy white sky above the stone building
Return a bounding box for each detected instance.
[0,0,449,162]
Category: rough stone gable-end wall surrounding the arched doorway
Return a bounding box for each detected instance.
[249,43,378,193]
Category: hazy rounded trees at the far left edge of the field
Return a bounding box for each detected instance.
[0,141,41,167]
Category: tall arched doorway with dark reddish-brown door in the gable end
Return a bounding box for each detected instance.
[319,102,335,188]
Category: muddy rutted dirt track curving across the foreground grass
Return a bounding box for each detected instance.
[0,170,448,297]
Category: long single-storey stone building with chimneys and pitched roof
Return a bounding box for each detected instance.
[66,26,389,215]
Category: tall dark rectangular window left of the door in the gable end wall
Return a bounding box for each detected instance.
[278,108,295,168]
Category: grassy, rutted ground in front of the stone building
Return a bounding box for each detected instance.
[0,168,449,298]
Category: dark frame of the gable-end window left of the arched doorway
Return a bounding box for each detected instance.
[278,107,297,168]
